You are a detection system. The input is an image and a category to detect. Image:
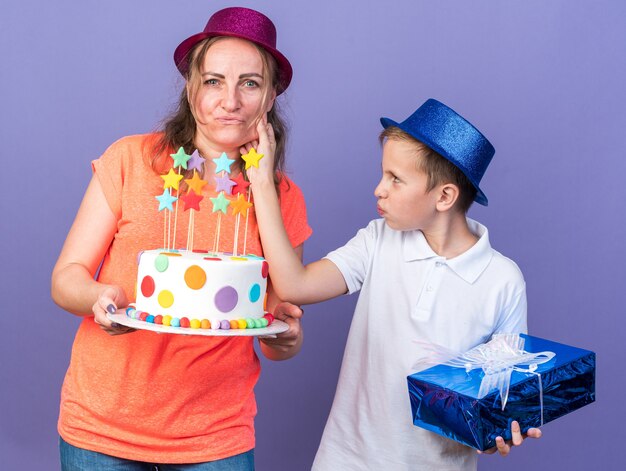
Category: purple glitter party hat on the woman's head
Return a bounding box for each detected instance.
[174,7,293,94]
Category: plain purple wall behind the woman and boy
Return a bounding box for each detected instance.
[0,0,626,471]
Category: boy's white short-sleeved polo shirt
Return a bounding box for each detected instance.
[313,219,526,471]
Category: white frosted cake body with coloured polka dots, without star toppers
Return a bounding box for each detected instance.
[135,249,268,324]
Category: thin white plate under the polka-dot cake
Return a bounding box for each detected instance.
[107,310,289,337]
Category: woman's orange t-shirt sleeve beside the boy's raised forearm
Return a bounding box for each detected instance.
[279,176,313,247]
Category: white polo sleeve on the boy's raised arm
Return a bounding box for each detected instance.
[324,221,380,294]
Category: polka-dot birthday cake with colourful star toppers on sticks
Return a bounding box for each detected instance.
[120,147,274,330]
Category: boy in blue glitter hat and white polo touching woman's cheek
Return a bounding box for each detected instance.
[249,99,540,471]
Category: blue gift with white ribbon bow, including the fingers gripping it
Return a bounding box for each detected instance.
[408,334,595,456]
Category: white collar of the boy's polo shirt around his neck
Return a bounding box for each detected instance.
[403,218,493,283]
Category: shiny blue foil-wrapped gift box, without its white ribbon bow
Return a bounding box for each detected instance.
[408,335,596,450]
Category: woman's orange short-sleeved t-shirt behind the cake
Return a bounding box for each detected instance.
[58,135,311,463]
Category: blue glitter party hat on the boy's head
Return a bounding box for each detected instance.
[380,98,496,206]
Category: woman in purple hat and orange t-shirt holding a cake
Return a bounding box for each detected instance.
[52,8,311,470]
